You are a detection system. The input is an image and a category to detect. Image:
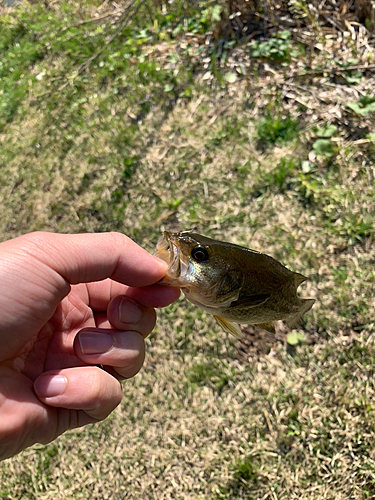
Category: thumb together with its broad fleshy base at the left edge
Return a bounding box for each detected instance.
[0,232,167,361]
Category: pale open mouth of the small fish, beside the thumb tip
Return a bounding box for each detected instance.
[154,231,188,287]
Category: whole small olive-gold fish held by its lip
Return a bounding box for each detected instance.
[154,231,315,338]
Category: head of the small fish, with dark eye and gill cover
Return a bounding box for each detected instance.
[155,231,242,308]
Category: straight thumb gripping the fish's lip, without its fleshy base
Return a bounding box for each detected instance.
[4,232,167,286]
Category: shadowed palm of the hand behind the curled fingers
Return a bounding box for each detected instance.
[0,281,121,454]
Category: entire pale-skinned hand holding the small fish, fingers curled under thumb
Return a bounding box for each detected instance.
[0,233,179,459]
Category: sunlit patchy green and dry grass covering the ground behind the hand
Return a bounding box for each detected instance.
[0,2,375,500]
